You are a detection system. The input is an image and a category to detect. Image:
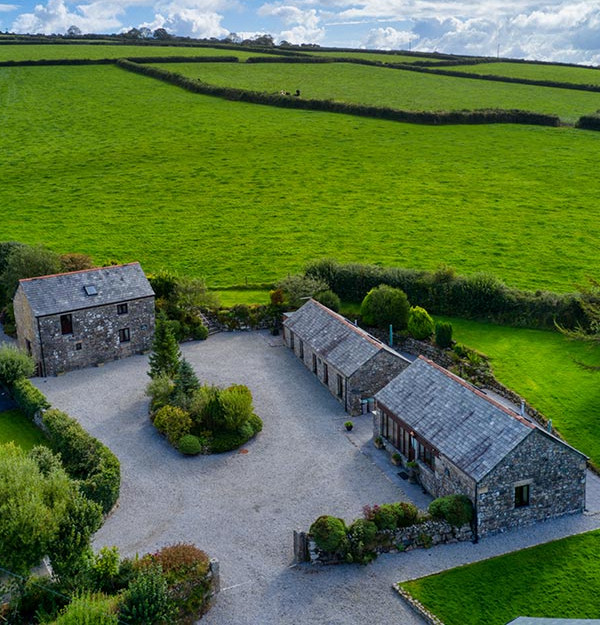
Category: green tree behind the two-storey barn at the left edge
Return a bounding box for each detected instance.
[0,245,62,302]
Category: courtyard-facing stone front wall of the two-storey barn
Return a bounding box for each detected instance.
[33,297,154,375]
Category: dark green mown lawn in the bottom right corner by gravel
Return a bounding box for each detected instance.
[402,531,600,625]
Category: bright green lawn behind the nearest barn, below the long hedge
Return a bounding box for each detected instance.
[438,318,600,467]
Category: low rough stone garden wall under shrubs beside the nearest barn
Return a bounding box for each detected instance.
[294,519,473,564]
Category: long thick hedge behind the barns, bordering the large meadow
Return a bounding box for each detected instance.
[305,259,587,329]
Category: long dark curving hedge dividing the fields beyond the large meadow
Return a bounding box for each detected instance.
[116,59,560,126]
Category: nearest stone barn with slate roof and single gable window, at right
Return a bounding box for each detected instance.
[374,356,586,536]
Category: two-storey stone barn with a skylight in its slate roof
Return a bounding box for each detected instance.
[14,263,154,376]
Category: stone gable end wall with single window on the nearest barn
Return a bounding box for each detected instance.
[476,430,586,536]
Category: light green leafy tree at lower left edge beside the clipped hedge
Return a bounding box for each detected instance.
[0,443,74,575]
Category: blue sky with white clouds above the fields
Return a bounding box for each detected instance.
[0,0,600,65]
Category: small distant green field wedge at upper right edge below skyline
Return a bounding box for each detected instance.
[444,63,600,85]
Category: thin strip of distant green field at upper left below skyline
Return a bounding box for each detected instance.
[0,43,274,61]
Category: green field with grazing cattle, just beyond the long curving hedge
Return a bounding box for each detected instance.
[150,63,600,123]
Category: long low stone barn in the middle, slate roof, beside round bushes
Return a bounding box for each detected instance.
[283,299,410,415]
